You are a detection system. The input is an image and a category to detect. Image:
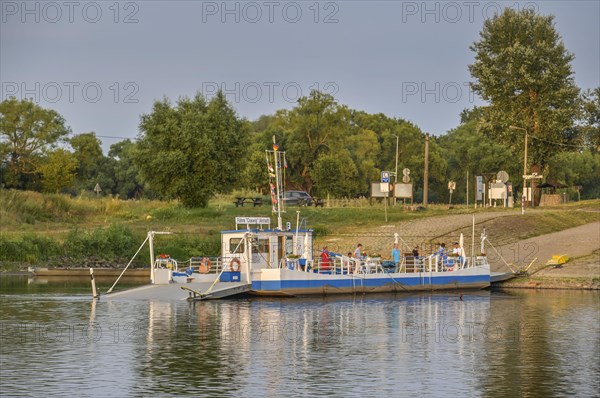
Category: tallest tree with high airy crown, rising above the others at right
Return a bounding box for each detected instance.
[469,8,579,167]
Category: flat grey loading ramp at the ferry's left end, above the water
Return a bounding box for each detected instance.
[102,282,252,301]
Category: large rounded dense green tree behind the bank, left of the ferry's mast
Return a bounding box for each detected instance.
[135,93,248,207]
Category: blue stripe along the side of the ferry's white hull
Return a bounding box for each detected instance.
[252,275,490,292]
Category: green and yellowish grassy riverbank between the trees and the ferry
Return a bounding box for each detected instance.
[0,190,600,271]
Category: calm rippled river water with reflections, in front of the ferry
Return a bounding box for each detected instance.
[0,277,600,397]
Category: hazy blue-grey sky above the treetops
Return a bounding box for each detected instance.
[0,0,600,150]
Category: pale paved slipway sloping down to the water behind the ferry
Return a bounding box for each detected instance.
[318,212,600,286]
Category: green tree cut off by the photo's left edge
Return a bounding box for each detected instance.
[0,97,70,189]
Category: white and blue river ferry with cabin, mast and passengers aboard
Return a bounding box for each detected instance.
[109,141,490,299]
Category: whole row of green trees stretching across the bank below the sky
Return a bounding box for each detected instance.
[0,9,600,207]
